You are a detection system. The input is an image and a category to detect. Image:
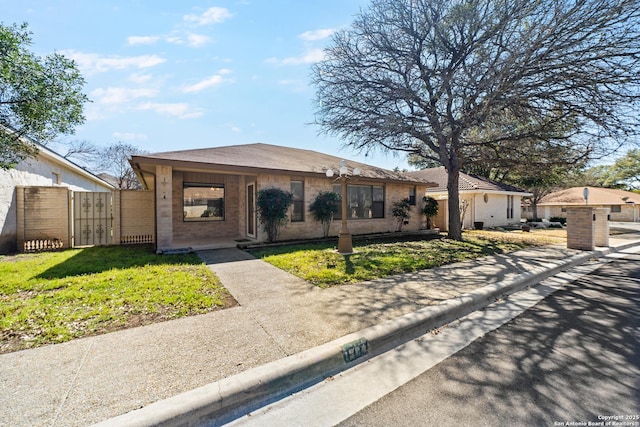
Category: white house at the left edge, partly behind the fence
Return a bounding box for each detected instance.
[0,144,113,254]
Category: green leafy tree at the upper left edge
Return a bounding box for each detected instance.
[0,24,88,169]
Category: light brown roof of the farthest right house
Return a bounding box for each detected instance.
[538,187,640,206]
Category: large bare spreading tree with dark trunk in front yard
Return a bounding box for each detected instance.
[312,0,640,240]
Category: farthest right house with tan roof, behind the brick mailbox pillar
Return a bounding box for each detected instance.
[525,187,640,222]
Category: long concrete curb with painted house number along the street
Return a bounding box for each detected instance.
[95,241,640,427]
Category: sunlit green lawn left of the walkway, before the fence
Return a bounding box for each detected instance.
[0,246,235,352]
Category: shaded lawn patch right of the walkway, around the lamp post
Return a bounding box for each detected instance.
[252,233,535,288]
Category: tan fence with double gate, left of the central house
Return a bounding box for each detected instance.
[16,187,155,252]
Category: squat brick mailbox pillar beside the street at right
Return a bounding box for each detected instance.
[567,206,609,251]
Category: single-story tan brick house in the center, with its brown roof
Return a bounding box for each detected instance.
[130,144,436,250]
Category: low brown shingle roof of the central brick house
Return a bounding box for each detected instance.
[132,143,430,183]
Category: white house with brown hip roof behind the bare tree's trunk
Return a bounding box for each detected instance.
[407,167,531,231]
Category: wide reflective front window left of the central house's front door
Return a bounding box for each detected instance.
[182,182,224,221]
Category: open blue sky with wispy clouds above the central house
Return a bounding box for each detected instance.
[0,0,408,169]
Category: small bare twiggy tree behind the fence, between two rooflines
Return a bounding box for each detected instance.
[95,142,143,190]
